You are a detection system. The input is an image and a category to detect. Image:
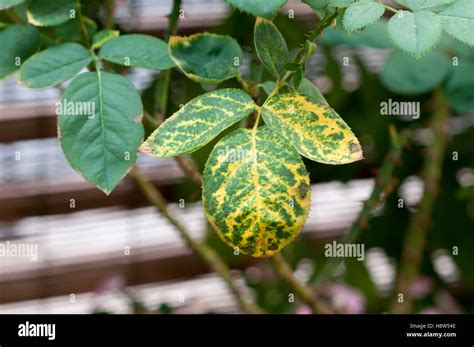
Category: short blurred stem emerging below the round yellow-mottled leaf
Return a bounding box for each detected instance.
[269,253,332,314]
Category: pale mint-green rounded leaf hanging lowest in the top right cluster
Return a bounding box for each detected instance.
[388,11,441,56]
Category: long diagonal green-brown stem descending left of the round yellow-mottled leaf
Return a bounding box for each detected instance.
[130,169,263,313]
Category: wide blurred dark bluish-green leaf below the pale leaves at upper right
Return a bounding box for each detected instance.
[380,52,451,95]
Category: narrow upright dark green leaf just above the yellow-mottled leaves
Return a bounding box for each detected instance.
[254,17,290,78]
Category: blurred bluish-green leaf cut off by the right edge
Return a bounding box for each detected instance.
[446,62,474,113]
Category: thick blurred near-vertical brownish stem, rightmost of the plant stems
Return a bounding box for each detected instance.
[392,90,449,313]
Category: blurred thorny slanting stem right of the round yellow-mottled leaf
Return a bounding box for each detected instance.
[315,127,409,283]
